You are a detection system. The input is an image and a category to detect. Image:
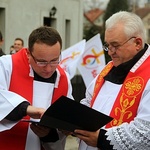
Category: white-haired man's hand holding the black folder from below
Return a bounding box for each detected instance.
[74,129,100,147]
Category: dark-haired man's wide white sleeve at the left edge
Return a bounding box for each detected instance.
[0,55,25,128]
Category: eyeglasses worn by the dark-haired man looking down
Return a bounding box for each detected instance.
[30,52,61,67]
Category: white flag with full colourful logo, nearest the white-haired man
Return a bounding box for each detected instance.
[77,34,106,87]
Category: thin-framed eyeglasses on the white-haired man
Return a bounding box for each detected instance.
[103,37,136,51]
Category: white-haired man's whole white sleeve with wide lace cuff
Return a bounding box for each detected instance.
[106,81,150,150]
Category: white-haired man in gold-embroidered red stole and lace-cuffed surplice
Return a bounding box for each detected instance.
[74,11,150,150]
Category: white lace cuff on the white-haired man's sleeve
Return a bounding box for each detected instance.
[106,119,150,150]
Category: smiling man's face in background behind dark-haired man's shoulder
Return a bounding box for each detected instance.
[13,38,24,53]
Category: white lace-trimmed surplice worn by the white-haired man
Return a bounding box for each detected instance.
[79,47,150,150]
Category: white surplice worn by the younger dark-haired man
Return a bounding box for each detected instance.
[0,55,73,150]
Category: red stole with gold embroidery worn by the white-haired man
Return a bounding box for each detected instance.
[91,57,150,128]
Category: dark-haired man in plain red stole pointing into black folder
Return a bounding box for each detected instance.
[0,26,73,150]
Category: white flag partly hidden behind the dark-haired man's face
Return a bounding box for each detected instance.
[60,40,86,79]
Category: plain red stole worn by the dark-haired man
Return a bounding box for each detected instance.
[0,49,68,150]
